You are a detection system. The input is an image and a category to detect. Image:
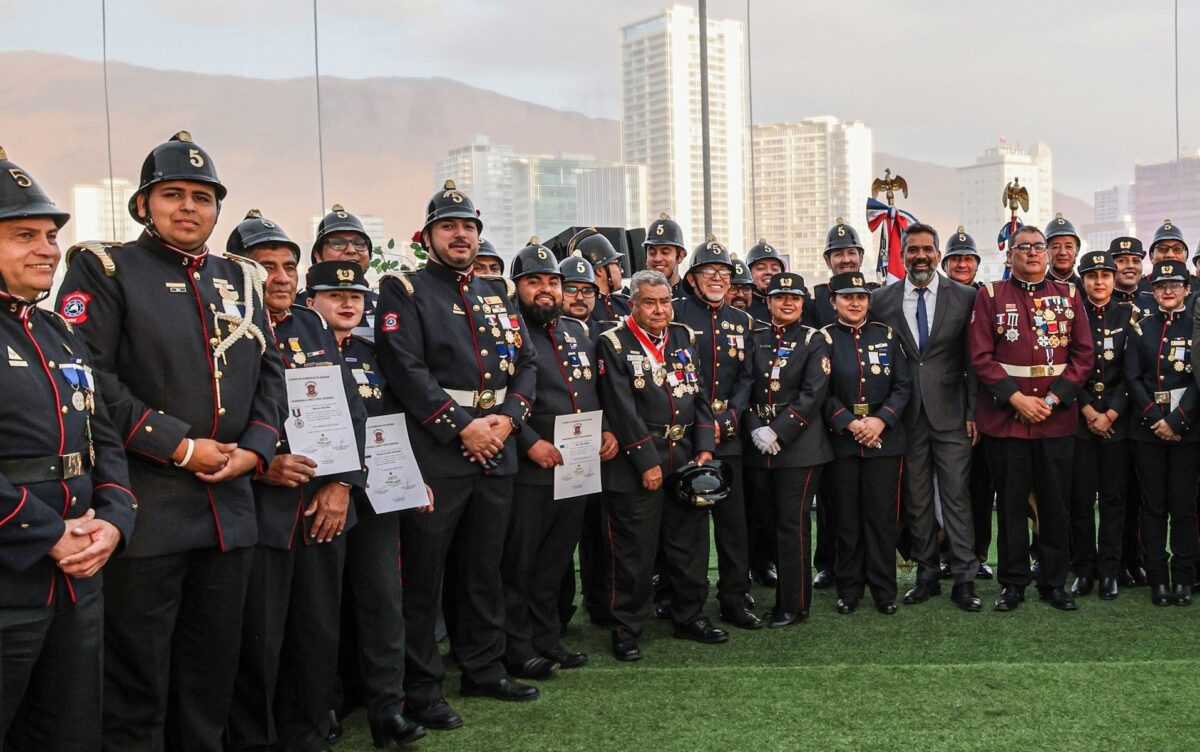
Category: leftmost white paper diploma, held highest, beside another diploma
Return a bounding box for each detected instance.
[283,366,361,475]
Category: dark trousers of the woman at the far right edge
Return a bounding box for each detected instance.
[1132,441,1200,585]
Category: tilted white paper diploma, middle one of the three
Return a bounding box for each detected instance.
[365,413,430,515]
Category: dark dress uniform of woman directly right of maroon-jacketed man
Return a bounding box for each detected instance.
[1070,274,1134,580]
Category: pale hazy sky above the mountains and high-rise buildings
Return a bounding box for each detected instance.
[0,0,1200,201]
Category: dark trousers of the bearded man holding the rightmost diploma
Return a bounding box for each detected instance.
[500,482,584,667]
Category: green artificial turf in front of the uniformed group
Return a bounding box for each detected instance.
[335,530,1200,752]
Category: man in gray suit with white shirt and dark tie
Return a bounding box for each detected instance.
[871,223,982,612]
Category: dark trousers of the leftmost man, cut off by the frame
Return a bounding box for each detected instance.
[0,587,104,752]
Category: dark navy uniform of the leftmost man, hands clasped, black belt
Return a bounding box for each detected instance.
[0,293,138,751]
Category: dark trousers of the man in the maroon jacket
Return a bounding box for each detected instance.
[984,435,1075,589]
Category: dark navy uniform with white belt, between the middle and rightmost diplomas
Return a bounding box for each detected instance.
[376,260,536,705]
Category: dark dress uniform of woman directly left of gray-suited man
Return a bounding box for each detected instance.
[823,311,912,608]
